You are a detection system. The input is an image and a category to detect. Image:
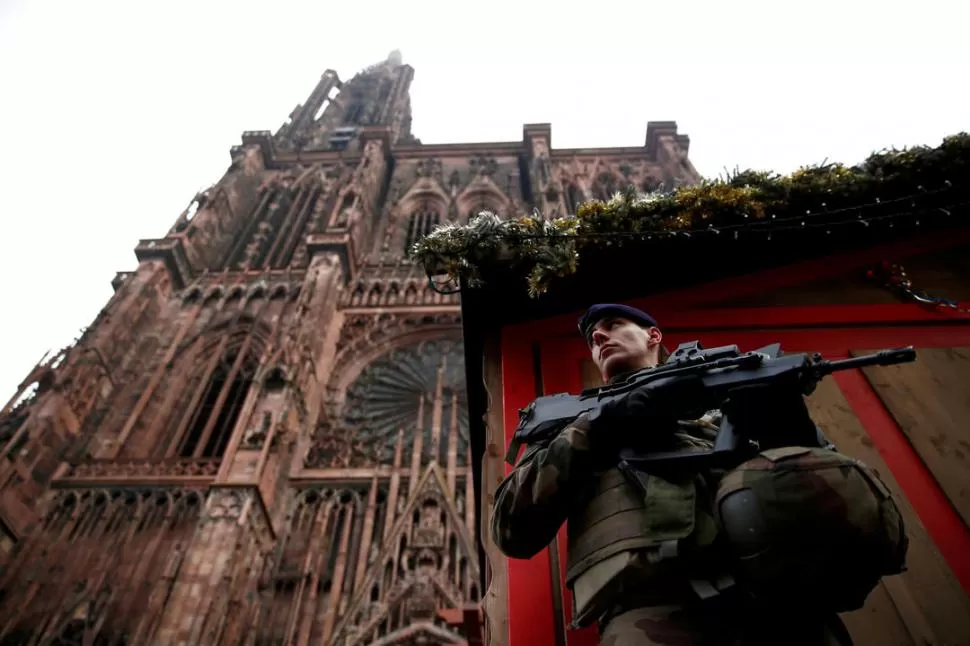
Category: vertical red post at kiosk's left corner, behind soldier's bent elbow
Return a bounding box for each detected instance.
[502,331,557,646]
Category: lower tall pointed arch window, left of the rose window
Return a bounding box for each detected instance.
[174,341,258,458]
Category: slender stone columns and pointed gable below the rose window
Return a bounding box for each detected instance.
[258,463,479,646]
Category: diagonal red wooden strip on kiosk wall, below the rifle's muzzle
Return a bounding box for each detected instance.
[834,370,970,594]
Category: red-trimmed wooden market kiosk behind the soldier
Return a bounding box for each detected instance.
[419,141,970,646]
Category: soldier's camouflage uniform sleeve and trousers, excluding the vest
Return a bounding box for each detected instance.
[491,411,851,646]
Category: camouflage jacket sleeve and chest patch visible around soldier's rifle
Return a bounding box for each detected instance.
[490,411,721,558]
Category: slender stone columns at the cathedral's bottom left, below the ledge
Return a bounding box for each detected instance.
[0,488,203,644]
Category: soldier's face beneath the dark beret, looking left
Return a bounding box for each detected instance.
[589,317,663,382]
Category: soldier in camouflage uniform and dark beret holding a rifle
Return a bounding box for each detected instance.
[491,304,864,646]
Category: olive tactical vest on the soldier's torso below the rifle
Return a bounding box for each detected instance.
[566,428,717,626]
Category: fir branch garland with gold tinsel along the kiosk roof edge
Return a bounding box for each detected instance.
[410,133,970,298]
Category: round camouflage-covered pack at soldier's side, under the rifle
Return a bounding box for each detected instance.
[714,447,909,612]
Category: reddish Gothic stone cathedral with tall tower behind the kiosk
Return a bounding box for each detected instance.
[0,52,698,646]
